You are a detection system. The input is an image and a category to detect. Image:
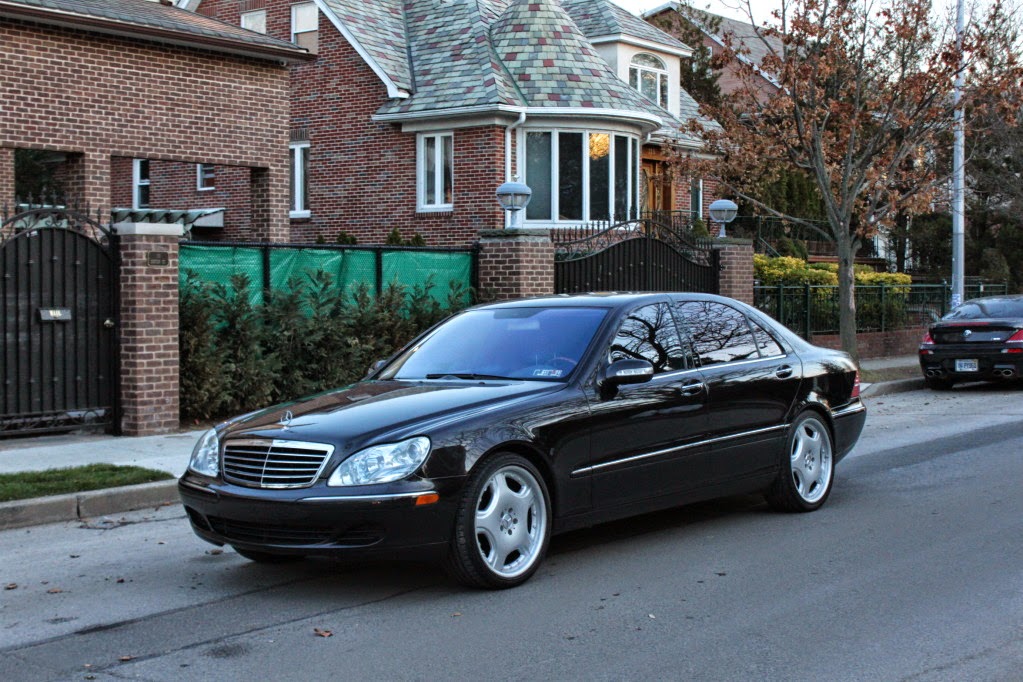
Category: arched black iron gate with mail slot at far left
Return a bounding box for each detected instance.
[0,208,118,437]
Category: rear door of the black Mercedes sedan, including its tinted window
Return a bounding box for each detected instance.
[674,300,802,483]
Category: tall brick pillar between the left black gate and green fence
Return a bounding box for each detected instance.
[115,223,182,436]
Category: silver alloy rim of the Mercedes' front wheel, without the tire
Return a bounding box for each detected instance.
[475,464,547,578]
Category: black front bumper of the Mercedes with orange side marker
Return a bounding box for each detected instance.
[178,472,461,558]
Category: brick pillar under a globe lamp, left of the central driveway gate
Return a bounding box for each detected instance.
[480,229,554,301]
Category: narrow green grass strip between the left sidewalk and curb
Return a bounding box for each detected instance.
[0,464,174,502]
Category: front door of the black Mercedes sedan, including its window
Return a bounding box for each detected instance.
[589,302,706,508]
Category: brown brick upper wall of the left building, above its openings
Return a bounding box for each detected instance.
[0,19,288,239]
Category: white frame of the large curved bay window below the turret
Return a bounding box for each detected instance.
[519,128,642,227]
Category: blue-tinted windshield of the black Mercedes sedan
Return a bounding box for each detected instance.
[381,308,608,381]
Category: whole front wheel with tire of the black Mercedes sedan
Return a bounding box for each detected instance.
[446,453,551,589]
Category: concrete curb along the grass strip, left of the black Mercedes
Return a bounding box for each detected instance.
[0,479,180,531]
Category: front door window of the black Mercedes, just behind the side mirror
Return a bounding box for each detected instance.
[609,303,685,374]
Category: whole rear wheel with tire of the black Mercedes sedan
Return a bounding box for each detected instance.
[766,412,835,512]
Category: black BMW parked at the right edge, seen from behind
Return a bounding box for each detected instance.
[920,295,1023,390]
